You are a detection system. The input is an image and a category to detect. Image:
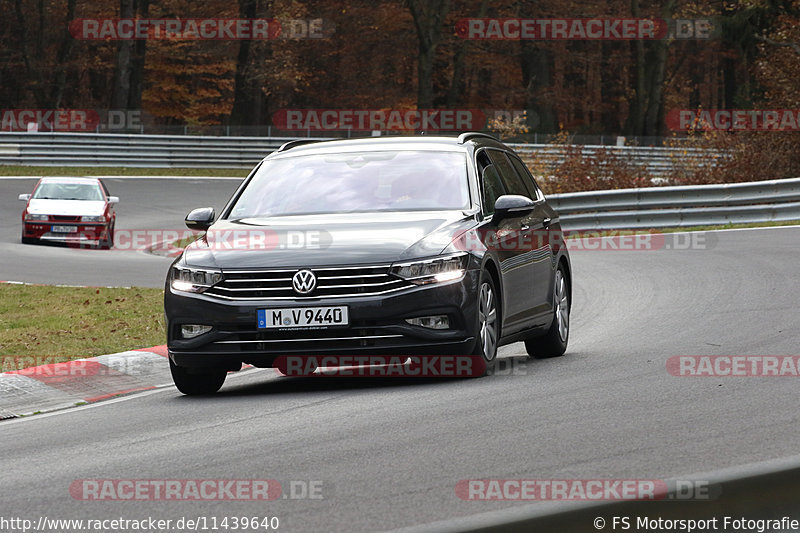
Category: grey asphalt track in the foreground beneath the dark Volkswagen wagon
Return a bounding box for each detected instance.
[0,204,800,531]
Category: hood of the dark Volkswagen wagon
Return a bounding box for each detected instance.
[183,211,475,270]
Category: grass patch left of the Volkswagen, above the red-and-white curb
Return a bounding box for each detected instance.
[0,283,166,372]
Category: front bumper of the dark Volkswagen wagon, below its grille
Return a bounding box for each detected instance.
[164,270,480,370]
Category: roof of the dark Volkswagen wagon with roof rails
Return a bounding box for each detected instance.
[267,132,507,159]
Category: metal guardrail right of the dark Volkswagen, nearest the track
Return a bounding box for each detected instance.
[547,178,800,230]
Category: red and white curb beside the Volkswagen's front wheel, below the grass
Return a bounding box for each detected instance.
[0,345,172,420]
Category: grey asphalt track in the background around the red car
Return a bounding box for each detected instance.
[0,177,241,287]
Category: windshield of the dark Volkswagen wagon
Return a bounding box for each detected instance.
[228,151,469,219]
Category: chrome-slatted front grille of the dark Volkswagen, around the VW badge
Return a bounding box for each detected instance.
[205,265,413,300]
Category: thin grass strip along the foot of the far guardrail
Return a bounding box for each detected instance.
[0,165,247,179]
